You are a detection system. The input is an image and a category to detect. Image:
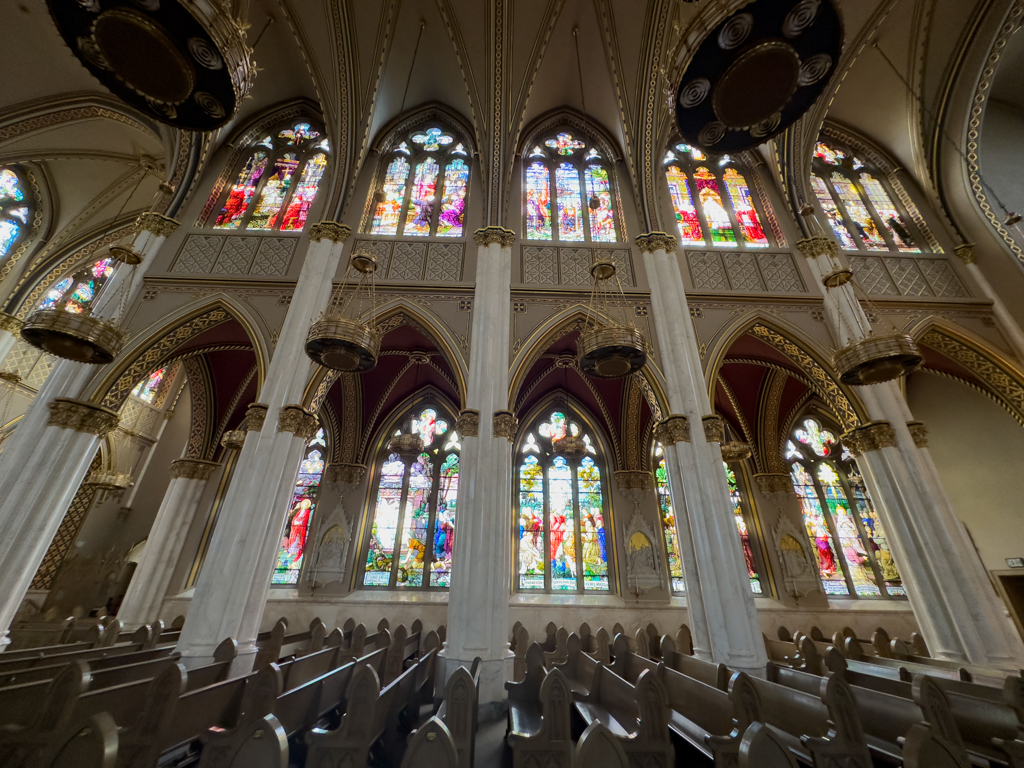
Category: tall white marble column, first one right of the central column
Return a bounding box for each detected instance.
[637,232,768,674]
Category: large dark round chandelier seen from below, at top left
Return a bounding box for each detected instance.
[47,0,255,131]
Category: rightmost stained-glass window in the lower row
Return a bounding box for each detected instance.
[785,418,906,597]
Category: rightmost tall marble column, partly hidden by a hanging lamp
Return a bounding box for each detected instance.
[797,237,1024,670]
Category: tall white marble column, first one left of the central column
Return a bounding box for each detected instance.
[177,221,350,674]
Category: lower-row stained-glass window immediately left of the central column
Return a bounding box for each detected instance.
[360,406,462,590]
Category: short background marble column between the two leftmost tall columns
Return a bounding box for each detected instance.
[118,459,219,629]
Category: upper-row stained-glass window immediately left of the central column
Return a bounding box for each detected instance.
[369,126,469,238]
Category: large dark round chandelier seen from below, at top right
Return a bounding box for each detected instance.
[675,0,843,154]
